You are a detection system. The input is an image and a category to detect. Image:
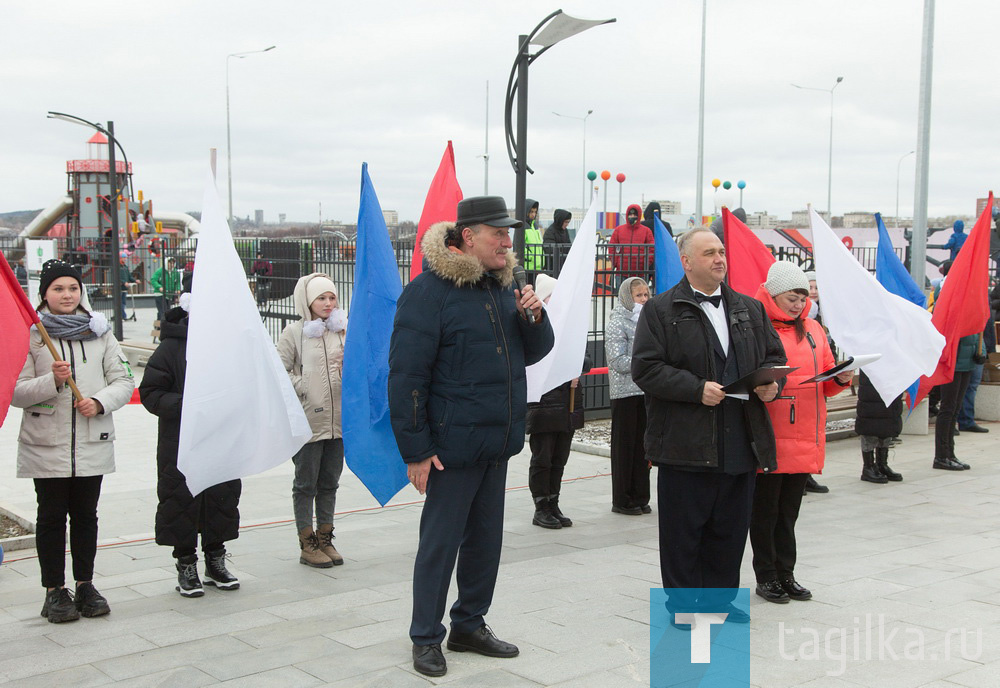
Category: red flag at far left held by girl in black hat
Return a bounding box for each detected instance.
[0,253,38,425]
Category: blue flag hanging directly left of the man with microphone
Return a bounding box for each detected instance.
[341,163,408,506]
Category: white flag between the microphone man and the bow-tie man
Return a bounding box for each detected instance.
[526,194,597,403]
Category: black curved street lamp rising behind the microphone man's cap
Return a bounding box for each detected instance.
[504,10,616,256]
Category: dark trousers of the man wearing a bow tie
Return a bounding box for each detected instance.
[657,465,754,602]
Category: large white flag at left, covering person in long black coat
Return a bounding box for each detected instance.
[177,172,312,495]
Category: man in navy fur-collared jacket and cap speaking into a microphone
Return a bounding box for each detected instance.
[389,196,553,676]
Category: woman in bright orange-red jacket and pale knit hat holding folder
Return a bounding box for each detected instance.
[750,262,853,603]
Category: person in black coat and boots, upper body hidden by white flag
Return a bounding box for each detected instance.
[854,372,903,485]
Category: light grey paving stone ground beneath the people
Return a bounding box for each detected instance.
[0,390,1000,688]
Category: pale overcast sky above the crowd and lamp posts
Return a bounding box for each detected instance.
[0,0,1000,222]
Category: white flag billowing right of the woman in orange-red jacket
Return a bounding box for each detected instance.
[809,208,944,406]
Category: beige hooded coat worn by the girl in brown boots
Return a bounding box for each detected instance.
[278,273,346,442]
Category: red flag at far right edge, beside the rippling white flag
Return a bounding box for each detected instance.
[913,191,993,406]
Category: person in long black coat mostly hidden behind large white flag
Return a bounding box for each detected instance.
[139,296,242,597]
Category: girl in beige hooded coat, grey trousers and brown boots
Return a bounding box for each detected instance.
[278,272,347,568]
